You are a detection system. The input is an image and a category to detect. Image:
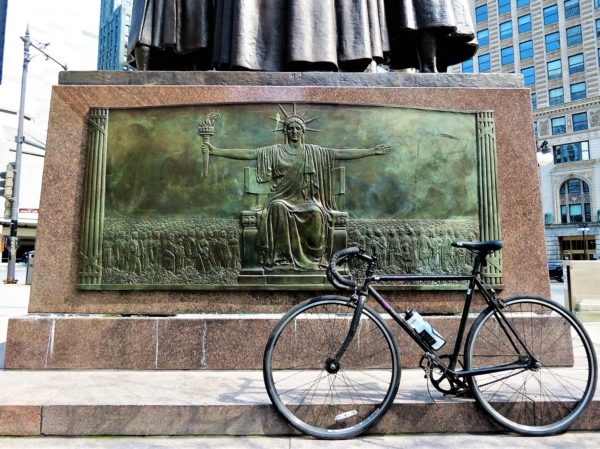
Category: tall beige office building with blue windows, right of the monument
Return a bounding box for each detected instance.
[460,0,600,260]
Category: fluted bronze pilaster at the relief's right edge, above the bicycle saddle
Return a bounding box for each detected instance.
[477,112,502,285]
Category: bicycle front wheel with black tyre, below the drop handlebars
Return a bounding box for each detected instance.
[263,296,400,439]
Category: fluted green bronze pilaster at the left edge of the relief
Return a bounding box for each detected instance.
[81,108,109,285]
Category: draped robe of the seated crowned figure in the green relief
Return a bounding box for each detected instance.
[256,144,335,271]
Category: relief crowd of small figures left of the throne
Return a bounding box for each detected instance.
[102,218,240,284]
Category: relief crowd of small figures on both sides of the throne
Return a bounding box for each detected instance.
[102,217,479,285]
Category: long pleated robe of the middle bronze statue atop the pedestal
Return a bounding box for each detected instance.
[214,0,389,71]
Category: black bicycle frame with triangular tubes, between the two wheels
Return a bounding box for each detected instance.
[350,256,535,378]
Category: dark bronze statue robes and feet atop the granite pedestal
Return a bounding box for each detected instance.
[129,0,477,72]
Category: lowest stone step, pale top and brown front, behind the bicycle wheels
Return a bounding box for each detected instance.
[0,370,600,436]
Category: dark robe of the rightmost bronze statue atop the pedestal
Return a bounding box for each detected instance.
[385,0,478,72]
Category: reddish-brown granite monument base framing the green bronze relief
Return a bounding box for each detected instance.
[6,72,549,369]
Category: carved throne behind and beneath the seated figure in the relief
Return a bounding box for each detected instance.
[238,167,348,285]
